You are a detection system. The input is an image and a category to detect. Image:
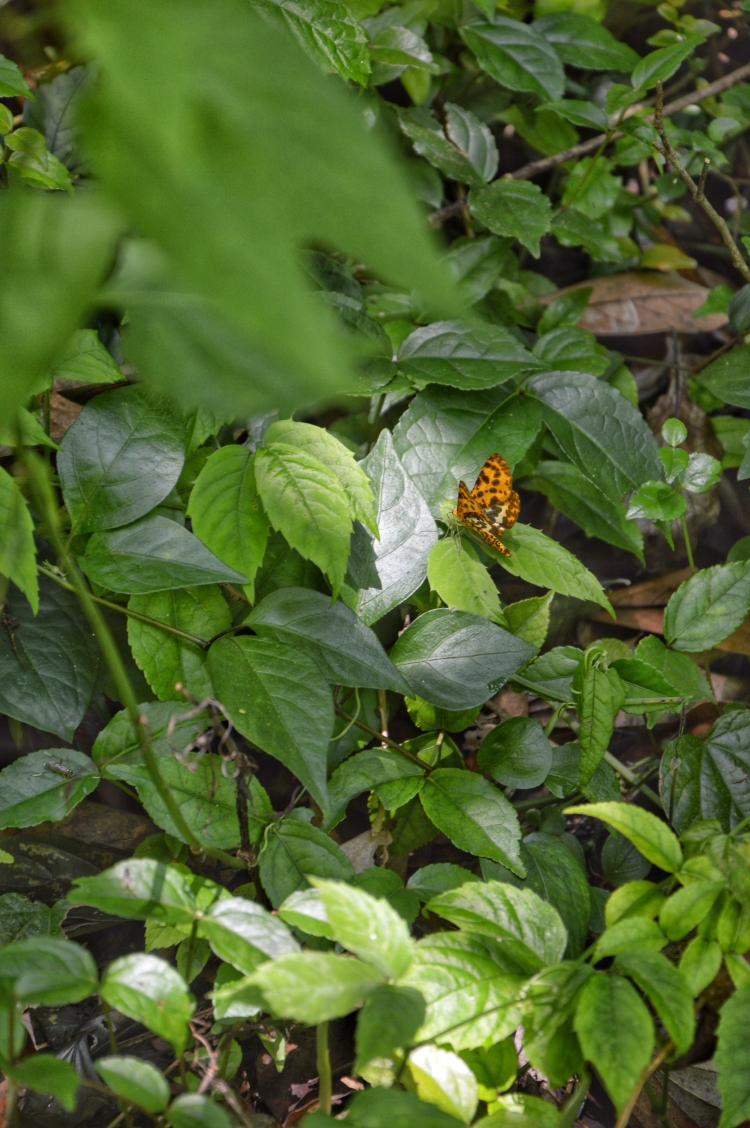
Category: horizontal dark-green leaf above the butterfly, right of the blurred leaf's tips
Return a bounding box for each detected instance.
[394,320,545,390]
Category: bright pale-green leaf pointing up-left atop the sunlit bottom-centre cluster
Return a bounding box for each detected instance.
[312,878,414,979]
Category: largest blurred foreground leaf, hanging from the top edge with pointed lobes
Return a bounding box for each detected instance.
[68,0,452,411]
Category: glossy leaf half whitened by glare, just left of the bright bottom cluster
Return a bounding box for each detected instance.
[198,897,299,975]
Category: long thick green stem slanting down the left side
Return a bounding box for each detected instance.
[21,448,244,870]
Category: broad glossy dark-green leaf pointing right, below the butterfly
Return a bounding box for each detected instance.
[390,608,533,710]
